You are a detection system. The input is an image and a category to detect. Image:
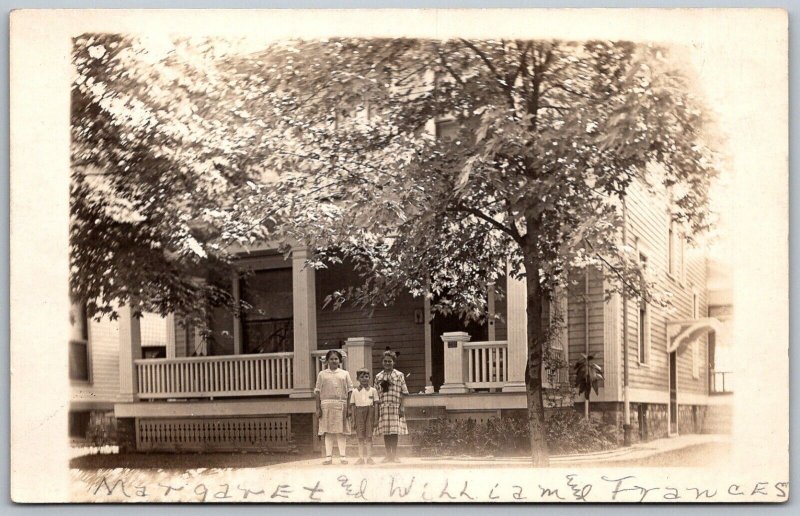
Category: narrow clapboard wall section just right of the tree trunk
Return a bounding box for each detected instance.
[567,270,605,381]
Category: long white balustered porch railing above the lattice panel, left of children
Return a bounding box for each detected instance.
[135,352,294,399]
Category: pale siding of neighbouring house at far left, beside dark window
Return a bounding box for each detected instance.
[72,319,119,403]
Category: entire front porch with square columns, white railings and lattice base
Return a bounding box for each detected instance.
[114,250,567,450]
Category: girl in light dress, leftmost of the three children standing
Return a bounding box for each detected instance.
[314,349,353,465]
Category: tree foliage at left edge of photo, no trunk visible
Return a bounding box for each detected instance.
[70,34,260,325]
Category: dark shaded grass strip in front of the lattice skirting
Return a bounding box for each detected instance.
[69,453,319,472]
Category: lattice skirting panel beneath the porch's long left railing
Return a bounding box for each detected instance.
[136,416,291,451]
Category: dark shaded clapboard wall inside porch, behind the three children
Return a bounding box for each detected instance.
[316,265,425,393]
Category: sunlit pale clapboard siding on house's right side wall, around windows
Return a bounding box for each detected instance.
[620,179,708,401]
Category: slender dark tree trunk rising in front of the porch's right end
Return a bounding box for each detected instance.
[525,255,550,468]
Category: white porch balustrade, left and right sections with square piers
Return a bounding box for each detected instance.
[126,332,524,402]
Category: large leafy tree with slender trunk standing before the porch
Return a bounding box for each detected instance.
[225,39,715,465]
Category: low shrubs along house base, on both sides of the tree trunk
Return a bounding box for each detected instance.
[411,410,617,456]
